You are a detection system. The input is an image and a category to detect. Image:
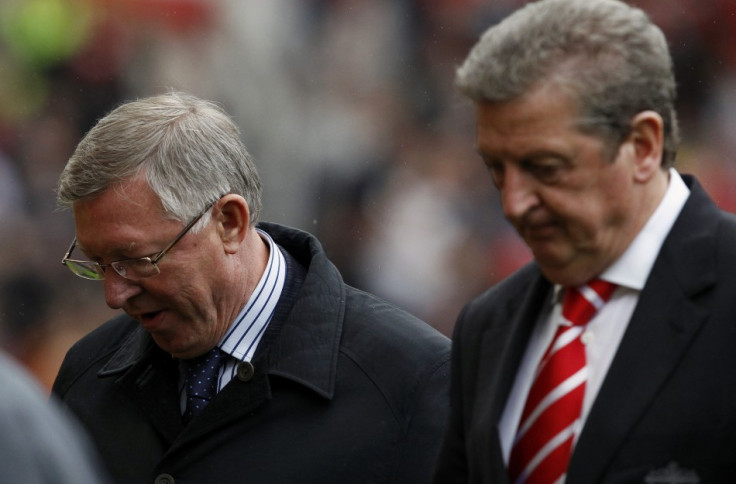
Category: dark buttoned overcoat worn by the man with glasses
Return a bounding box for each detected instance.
[53,224,450,484]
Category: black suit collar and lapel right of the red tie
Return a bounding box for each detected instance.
[568,176,718,482]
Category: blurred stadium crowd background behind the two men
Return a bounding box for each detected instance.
[0,0,736,387]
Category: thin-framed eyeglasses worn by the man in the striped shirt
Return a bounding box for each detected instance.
[61,202,215,281]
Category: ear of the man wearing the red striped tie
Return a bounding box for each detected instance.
[627,111,664,182]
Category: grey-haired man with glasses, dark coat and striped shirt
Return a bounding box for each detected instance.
[53,93,449,483]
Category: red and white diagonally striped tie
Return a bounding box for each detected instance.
[509,279,616,484]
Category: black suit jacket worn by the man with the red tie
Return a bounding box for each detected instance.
[435,176,736,484]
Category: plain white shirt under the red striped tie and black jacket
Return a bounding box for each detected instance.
[499,168,690,463]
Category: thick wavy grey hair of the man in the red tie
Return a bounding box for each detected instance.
[456,0,679,168]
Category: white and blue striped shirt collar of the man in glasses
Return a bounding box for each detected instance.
[218,229,286,361]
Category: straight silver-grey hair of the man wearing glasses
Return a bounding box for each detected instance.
[57,92,261,230]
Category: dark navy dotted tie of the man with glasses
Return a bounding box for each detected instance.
[181,347,222,424]
